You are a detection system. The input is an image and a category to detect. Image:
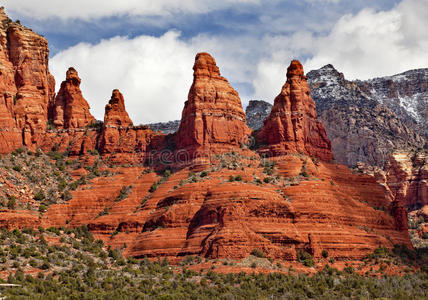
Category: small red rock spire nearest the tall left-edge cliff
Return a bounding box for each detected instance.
[52,68,95,129]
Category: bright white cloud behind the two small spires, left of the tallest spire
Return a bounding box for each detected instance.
[50,31,196,124]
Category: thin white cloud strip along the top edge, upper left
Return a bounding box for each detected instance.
[3,0,259,20]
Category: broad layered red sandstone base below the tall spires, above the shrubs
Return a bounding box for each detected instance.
[37,155,411,260]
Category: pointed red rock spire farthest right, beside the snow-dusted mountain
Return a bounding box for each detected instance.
[257,60,333,161]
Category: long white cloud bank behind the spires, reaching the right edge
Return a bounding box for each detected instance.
[51,0,428,123]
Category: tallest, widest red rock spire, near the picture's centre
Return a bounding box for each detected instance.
[176,53,249,156]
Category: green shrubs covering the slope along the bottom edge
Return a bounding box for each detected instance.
[0,226,428,299]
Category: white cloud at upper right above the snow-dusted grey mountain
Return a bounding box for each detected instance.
[305,0,428,79]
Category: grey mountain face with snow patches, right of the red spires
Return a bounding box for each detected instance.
[307,65,428,168]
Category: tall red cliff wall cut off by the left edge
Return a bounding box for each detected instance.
[0,8,55,153]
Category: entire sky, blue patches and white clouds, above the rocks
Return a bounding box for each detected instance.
[1,0,428,123]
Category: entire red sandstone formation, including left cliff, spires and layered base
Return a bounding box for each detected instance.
[0,8,411,260]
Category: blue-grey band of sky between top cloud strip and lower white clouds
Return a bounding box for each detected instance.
[6,0,399,55]
